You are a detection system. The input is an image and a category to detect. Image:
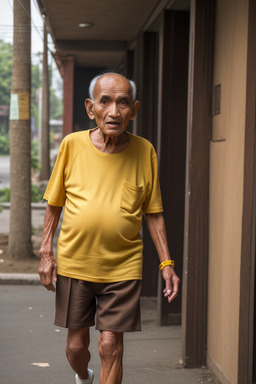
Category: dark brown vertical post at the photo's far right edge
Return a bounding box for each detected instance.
[238,0,256,384]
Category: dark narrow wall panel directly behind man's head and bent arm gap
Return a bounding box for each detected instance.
[136,32,159,296]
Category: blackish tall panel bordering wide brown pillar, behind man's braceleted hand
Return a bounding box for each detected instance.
[158,11,189,325]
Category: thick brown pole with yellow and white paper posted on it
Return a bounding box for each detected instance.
[8,0,33,259]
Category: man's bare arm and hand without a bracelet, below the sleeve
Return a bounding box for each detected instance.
[38,204,62,292]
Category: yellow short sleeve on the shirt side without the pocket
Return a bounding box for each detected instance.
[44,143,66,207]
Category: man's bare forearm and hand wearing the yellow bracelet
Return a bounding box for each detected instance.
[145,213,180,303]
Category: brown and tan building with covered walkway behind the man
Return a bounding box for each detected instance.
[37,0,256,384]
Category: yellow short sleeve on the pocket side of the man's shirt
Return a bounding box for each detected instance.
[142,151,163,213]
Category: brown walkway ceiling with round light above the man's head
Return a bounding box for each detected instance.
[37,0,189,69]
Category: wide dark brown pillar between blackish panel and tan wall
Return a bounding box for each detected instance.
[182,0,215,368]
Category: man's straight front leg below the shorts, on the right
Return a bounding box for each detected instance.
[99,331,123,384]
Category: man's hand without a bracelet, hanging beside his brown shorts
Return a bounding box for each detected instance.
[38,249,57,292]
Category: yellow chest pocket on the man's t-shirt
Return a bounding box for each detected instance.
[120,181,144,213]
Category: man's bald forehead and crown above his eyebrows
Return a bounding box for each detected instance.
[94,74,132,97]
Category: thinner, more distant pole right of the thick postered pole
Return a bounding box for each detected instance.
[40,18,50,180]
